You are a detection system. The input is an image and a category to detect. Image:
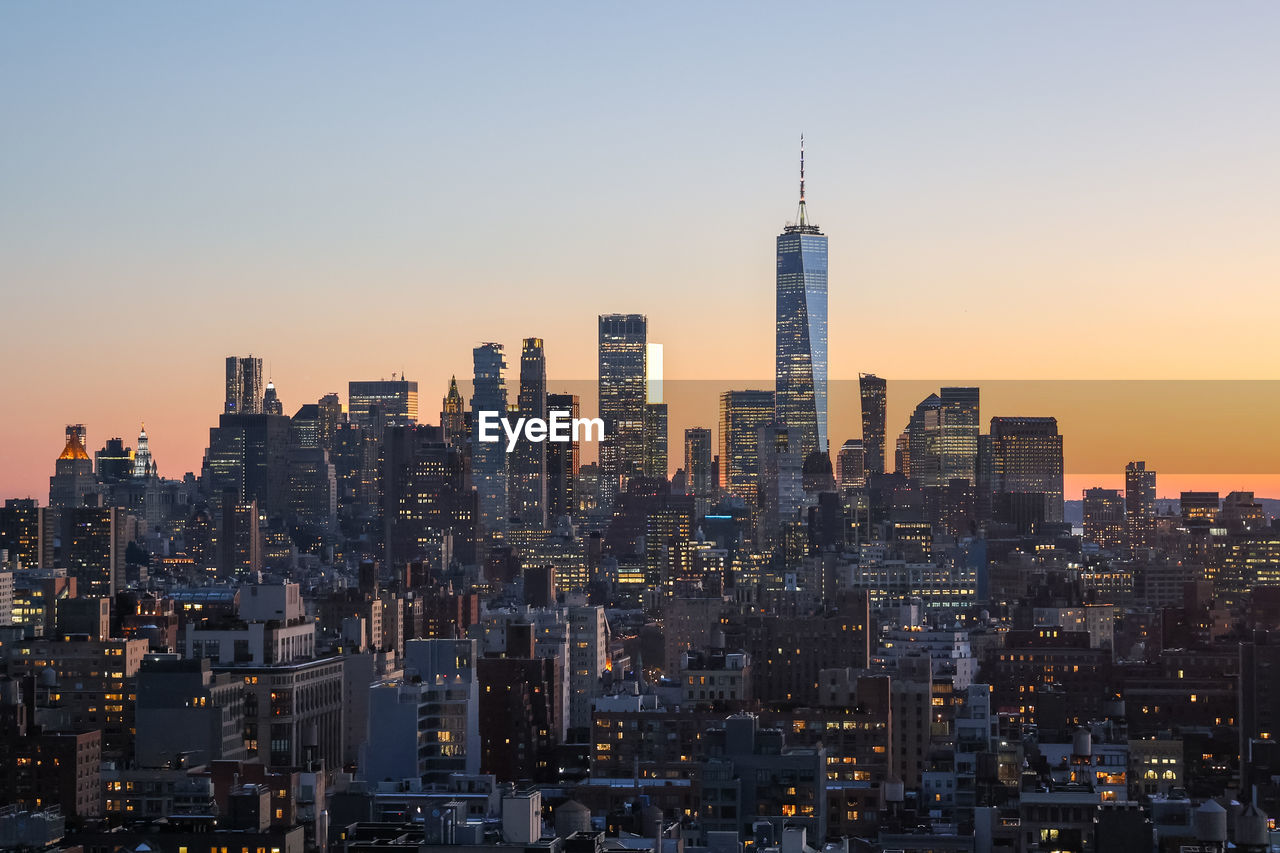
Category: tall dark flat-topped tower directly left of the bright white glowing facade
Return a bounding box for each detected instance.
[598,314,649,507]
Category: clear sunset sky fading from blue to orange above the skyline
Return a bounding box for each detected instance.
[0,1,1280,498]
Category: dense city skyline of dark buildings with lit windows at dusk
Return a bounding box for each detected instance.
[0,149,1280,853]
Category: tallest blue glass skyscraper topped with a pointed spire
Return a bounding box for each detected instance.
[774,138,827,457]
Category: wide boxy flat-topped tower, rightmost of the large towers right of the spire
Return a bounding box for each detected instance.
[991,418,1064,526]
